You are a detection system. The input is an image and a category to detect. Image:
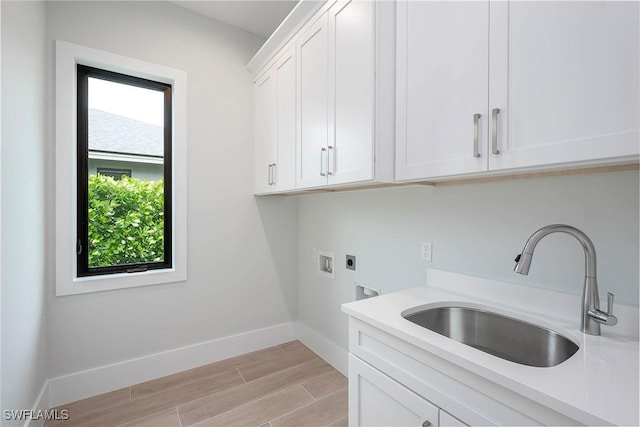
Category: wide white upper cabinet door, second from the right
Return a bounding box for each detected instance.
[396,1,489,180]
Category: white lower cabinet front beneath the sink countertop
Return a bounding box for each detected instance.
[349,317,581,427]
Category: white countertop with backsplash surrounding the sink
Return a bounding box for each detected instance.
[342,269,640,426]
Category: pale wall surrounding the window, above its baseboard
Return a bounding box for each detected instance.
[47,1,297,378]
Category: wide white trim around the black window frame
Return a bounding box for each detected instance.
[55,40,187,296]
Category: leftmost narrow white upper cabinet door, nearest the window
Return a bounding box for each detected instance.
[253,72,277,194]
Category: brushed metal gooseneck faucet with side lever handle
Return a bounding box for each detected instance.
[513,224,618,335]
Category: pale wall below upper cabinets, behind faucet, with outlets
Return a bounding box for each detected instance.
[298,172,639,349]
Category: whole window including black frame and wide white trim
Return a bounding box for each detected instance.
[55,41,187,296]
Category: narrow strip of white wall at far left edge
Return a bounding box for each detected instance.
[0,2,52,425]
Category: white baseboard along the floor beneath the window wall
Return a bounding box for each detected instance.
[48,322,296,410]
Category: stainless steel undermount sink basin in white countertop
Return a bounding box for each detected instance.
[403,307,578,367]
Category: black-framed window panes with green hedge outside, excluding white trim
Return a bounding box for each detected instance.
[77,65,172,277]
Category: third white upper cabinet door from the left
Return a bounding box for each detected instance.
[296,13,329,188]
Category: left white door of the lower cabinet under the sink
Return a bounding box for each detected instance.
[349,354,438,427]
